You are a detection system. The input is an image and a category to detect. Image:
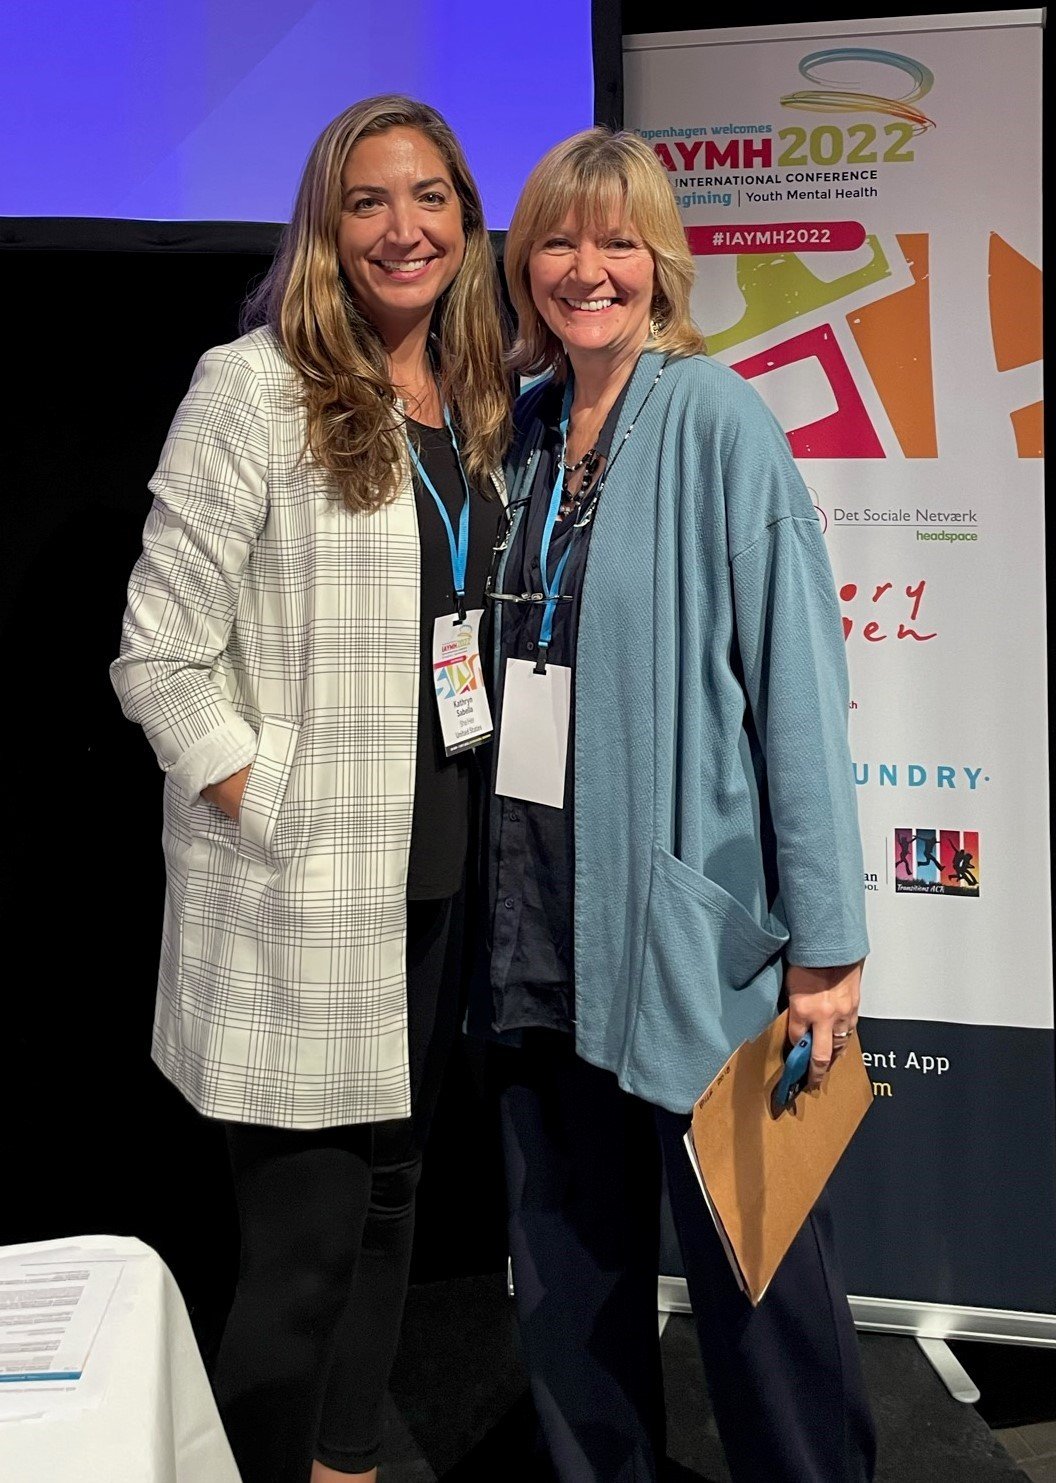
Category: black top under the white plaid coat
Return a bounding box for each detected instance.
[406,418,501,902]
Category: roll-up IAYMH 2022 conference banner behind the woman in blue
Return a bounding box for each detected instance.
[624,10,1056,1344]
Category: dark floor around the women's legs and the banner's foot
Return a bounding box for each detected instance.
[380,1275,1056,1483]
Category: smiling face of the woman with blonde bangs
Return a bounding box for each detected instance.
[528,217,656,365]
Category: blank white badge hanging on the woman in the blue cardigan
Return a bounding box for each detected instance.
[495,658,572,808]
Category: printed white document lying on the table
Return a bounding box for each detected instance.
[0,1246,126,1421]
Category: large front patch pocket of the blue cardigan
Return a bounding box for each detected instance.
[627,845,788,1109]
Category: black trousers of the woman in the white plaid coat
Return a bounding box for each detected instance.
[214,896,463,1483]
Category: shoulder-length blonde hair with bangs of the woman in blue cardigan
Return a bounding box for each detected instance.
[503,126,704,380]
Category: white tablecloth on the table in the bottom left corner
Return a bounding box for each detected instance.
[0,1235,239,1483]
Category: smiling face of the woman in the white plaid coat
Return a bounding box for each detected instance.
[337,128,466,346]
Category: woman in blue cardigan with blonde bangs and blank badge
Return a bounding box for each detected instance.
[479,129,875,1483]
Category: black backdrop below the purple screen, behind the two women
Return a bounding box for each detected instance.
[0,221,506,1352]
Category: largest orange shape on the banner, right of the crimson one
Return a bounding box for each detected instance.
[847,231,939,458]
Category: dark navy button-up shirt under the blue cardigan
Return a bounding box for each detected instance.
[489,387,626,1032]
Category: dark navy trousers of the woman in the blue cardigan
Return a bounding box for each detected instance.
[491,1031,875,1483]
